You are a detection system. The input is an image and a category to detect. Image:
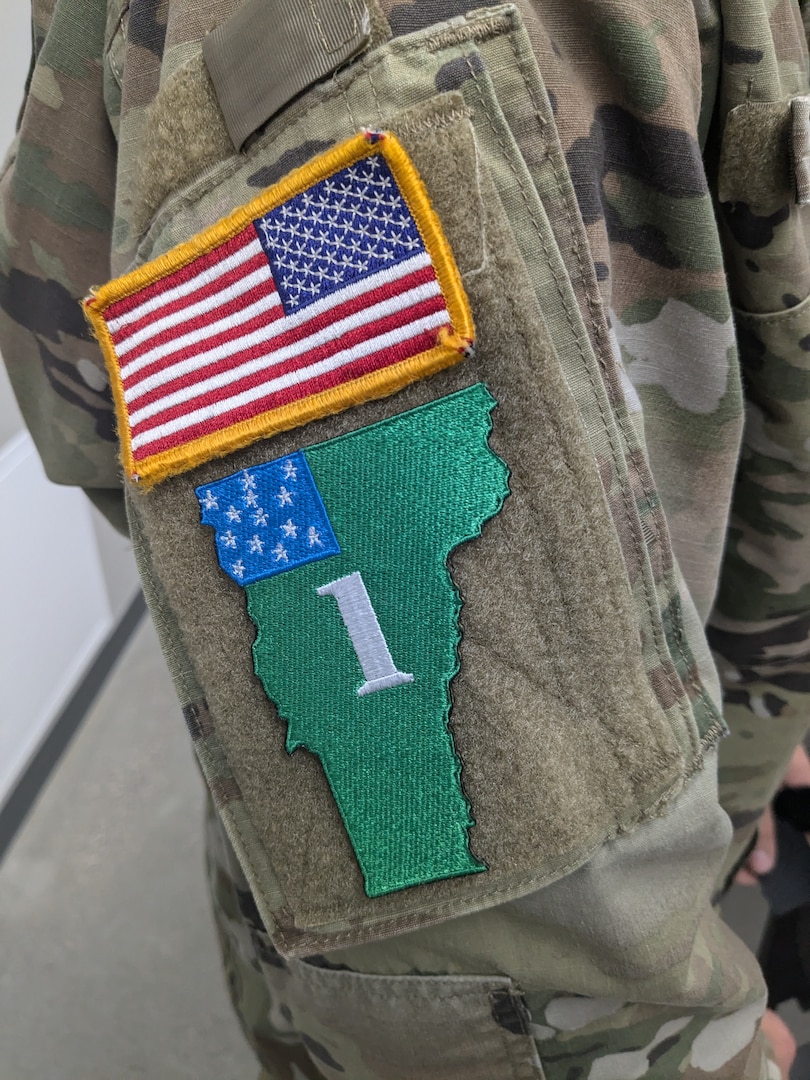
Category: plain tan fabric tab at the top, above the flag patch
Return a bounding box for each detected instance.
[203,0,372,150]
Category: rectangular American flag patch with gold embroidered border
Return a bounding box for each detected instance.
[84,133,473,486]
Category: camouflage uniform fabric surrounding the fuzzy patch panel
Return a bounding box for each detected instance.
[0,0,810,1080]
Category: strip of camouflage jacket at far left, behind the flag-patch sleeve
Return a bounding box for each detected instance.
[0,0,125,528]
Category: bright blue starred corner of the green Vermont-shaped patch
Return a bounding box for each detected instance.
[197,453,340,585]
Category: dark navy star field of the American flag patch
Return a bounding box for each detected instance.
[255,154,424,314]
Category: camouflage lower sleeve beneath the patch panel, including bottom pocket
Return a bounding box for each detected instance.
[207,761,779,1080]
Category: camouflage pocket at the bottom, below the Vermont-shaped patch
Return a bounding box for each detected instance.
[288,960,544,1080]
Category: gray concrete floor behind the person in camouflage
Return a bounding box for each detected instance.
[0,621,810,1080]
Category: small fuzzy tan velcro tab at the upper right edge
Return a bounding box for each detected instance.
[717,96,810,208]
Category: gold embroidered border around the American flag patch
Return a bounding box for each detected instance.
[83,133,475,489]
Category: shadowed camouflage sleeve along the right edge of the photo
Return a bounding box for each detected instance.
[708,4,810,873]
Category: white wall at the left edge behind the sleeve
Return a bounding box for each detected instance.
[0,6,137,805]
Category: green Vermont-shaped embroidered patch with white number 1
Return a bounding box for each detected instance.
[197,383,509,896]
